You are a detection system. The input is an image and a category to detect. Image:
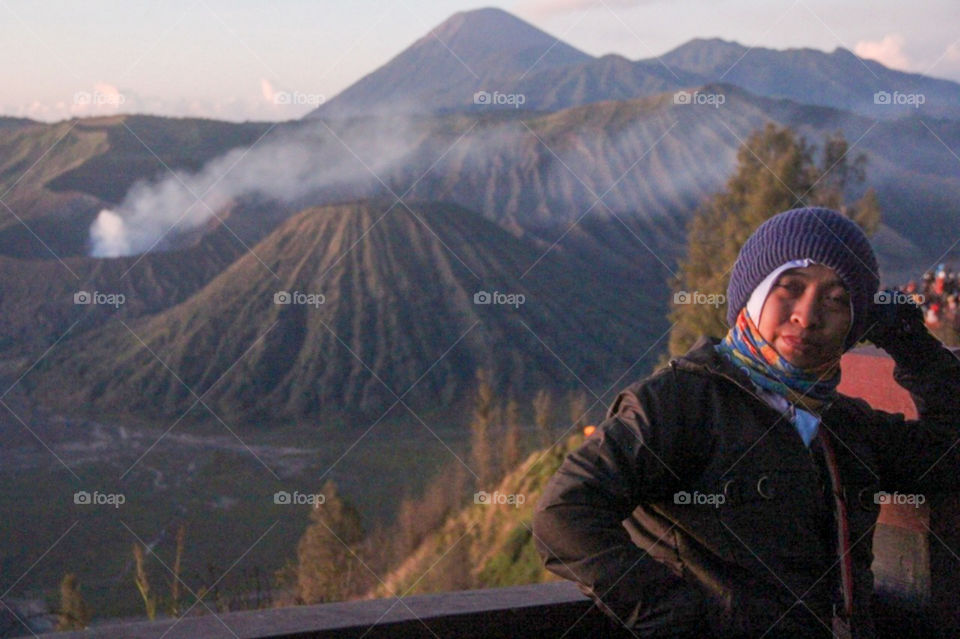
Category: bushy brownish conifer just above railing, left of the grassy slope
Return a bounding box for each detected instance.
[296,481,365,604]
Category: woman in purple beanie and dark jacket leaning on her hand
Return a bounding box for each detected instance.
[534,208,960,638]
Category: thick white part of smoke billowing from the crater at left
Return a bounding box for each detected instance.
[90,119,428,257]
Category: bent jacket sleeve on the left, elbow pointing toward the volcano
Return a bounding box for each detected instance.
[533,371,706,636]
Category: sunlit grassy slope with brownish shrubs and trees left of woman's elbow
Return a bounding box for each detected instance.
[270,378,589,605]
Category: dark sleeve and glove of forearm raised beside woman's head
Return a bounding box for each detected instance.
[872,331,960,492]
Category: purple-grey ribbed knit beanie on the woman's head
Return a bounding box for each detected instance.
[727,207,880,349]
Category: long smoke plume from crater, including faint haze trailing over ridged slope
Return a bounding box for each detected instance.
[90,104,688,257]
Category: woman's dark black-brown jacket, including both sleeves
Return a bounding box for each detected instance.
[533,332,960,637]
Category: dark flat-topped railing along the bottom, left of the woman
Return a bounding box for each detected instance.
[30,582,620,639]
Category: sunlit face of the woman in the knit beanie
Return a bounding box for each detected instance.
[757,264,853,368]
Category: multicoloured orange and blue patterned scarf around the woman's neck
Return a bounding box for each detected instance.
[716,307,840,413]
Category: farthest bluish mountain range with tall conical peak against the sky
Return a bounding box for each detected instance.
[306,9,960,118]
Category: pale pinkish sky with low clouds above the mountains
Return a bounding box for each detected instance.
[0,0,960,121]
